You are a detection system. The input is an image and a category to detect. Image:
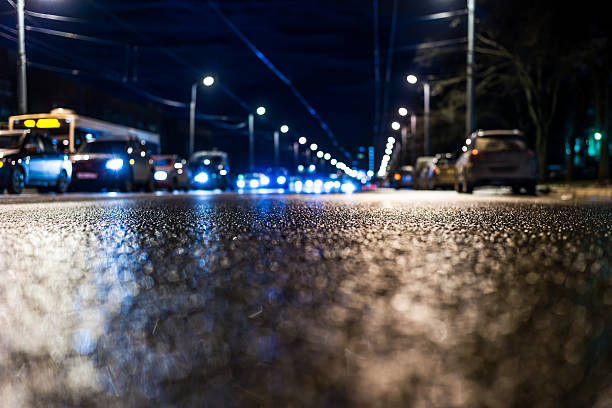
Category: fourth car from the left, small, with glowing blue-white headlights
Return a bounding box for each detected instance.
[189,150,231,190]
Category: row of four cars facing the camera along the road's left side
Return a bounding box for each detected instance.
[0,130,229,194]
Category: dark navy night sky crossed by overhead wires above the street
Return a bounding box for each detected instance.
[0,0,465,171]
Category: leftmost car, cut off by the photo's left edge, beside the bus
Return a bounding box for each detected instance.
[0,130,72,194]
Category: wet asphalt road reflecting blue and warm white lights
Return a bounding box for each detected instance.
[0,192,612,407]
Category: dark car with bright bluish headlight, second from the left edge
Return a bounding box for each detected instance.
[71,140,155,192]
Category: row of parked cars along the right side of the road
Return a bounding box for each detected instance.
[392,130,537,194]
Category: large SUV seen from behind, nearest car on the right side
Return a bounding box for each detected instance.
[455,130,537,194]
